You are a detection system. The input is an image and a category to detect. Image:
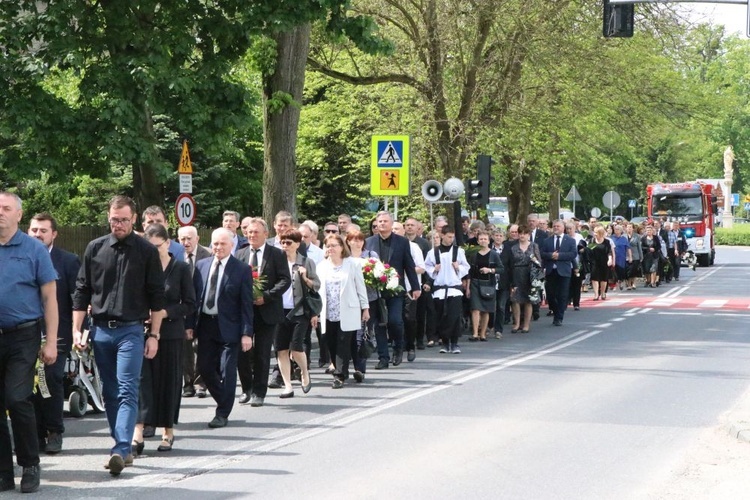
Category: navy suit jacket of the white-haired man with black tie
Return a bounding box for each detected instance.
[193,256,254,344]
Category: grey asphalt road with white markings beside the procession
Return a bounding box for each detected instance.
[14,248,750,500]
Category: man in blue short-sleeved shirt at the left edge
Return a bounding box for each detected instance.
[0,192,58,493]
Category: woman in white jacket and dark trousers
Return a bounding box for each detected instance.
[317,234,370,389]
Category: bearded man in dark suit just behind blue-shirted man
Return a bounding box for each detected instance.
[29,212,81,455]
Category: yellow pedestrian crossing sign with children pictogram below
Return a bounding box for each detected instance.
[370,135,410,196]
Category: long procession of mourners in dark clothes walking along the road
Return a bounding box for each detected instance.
[0,193,686,492]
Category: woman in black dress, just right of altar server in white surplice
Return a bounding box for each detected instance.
[467,230,502,342]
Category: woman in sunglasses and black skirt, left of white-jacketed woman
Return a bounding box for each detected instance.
[273,229,320,399]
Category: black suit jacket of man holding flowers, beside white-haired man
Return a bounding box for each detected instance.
[237,241,292,325]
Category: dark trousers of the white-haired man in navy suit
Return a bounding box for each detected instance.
[196,315,240,418]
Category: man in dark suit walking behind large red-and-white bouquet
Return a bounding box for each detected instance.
[365,212,422,370]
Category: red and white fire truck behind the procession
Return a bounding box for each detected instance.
[646,181,716,267]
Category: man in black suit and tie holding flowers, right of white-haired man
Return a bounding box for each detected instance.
[237,217,292,407]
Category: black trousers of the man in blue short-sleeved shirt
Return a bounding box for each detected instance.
[0,324,42,478]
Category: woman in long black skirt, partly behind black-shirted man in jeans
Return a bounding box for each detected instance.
[133,224,195,454]
